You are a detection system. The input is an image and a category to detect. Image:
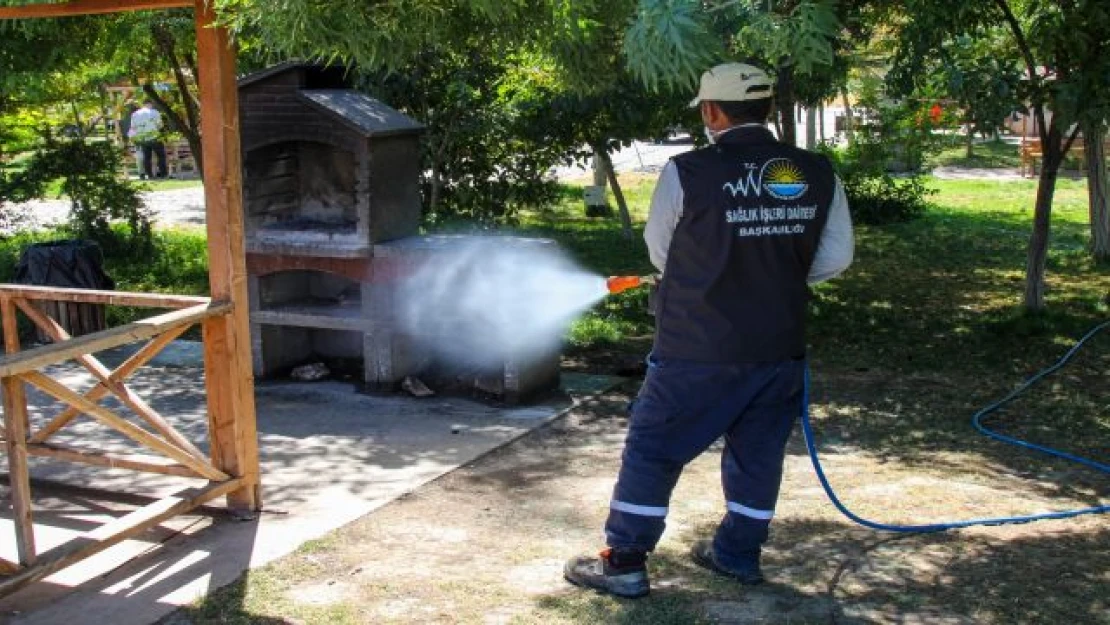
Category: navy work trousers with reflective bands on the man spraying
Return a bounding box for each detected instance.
[605,359,806,566]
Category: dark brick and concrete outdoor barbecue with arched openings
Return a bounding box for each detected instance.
[239,63,558,402]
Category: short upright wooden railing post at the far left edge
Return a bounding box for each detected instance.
[0,296,36,566]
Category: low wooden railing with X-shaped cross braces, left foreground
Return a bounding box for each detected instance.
[0,284,246,595]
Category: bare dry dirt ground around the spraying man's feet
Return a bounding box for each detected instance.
[163,364,1110,625]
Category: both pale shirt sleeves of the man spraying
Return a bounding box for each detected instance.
[644,161,856,284]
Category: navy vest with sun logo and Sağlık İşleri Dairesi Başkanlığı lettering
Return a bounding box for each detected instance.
[653,127,836,363]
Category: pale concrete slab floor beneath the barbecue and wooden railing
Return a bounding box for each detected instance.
[0,349,616,625]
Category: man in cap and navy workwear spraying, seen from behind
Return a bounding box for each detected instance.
[564,63,854,597]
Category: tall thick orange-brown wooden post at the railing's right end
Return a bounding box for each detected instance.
[195,0,262,511]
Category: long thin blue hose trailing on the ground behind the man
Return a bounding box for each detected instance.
[801,321,1110,533]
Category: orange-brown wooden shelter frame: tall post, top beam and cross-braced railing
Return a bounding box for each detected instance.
[0,0,261,595]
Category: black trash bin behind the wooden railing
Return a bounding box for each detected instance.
[16,240,115,342]
